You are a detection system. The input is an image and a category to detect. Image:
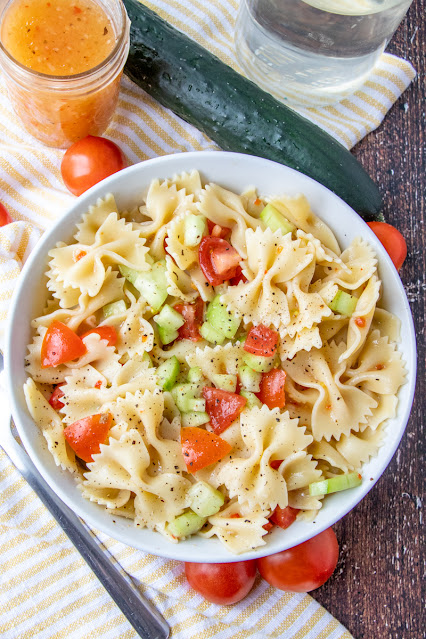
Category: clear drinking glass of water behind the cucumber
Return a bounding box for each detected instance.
[235,0,412,106]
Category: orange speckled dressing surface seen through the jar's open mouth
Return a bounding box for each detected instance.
[2,0,116,76]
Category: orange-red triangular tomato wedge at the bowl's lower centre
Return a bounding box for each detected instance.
[181,426,232,473]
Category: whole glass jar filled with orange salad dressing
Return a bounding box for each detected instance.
[0,0,129,148]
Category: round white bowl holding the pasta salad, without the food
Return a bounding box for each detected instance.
[5,151,416,562]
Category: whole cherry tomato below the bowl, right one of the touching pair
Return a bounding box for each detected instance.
[257,528,339,592]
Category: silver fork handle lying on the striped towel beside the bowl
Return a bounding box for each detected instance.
[0,352,170,639]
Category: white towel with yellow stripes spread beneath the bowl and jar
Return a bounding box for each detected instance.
[0,0,415,639]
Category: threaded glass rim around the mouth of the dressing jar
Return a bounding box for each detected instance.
[0,0,130,84]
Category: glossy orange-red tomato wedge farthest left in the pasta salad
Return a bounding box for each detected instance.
[41,320,86,368]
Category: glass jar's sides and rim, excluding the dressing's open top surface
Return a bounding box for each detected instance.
[0,0,130,148]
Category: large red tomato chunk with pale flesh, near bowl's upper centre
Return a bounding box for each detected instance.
[198,235,241,286]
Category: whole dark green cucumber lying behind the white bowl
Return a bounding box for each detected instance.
[124,0,383,221]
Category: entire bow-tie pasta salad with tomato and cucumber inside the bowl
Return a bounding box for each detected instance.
[24,170,405,553]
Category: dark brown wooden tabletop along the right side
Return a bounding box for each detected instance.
[311,0,426,639]
